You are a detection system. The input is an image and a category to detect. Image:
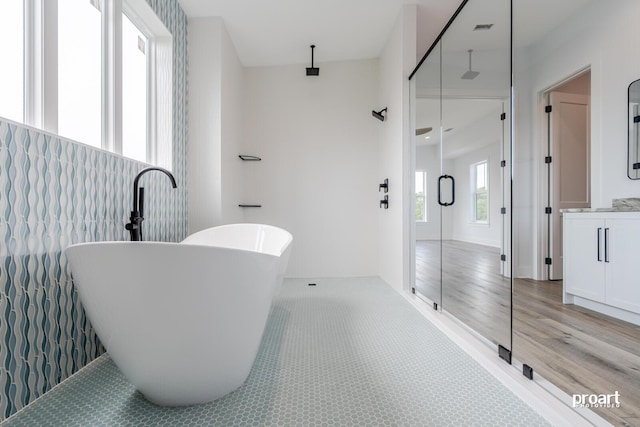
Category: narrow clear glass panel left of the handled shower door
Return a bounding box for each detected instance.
[412,43,443,309]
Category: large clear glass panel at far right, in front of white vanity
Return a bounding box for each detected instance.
[510,0,640,426]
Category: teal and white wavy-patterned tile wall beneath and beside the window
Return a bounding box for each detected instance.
[0,0,187,421]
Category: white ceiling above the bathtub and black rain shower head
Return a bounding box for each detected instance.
[178,0,461,67]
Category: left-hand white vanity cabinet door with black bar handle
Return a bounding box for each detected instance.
[563,216,605,302]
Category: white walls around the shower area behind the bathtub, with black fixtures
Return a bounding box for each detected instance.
[188,5,416,280]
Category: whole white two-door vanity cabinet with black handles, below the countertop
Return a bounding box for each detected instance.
[563,212,640,324]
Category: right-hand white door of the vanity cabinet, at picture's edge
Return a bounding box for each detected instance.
[606,219,640,313]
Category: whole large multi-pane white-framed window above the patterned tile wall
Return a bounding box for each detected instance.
[0,0,173,169]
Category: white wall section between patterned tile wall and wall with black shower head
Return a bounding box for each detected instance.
[187,17,244,233]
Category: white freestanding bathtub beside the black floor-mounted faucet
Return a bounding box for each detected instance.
[66,224,292,406]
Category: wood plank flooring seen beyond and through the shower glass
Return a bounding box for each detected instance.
[416,241,640,426]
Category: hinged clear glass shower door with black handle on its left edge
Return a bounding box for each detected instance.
[441,0,511,349]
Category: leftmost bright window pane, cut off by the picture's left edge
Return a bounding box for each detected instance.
[0,0,24,122]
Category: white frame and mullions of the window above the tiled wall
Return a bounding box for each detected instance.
[14,0,173,170]
